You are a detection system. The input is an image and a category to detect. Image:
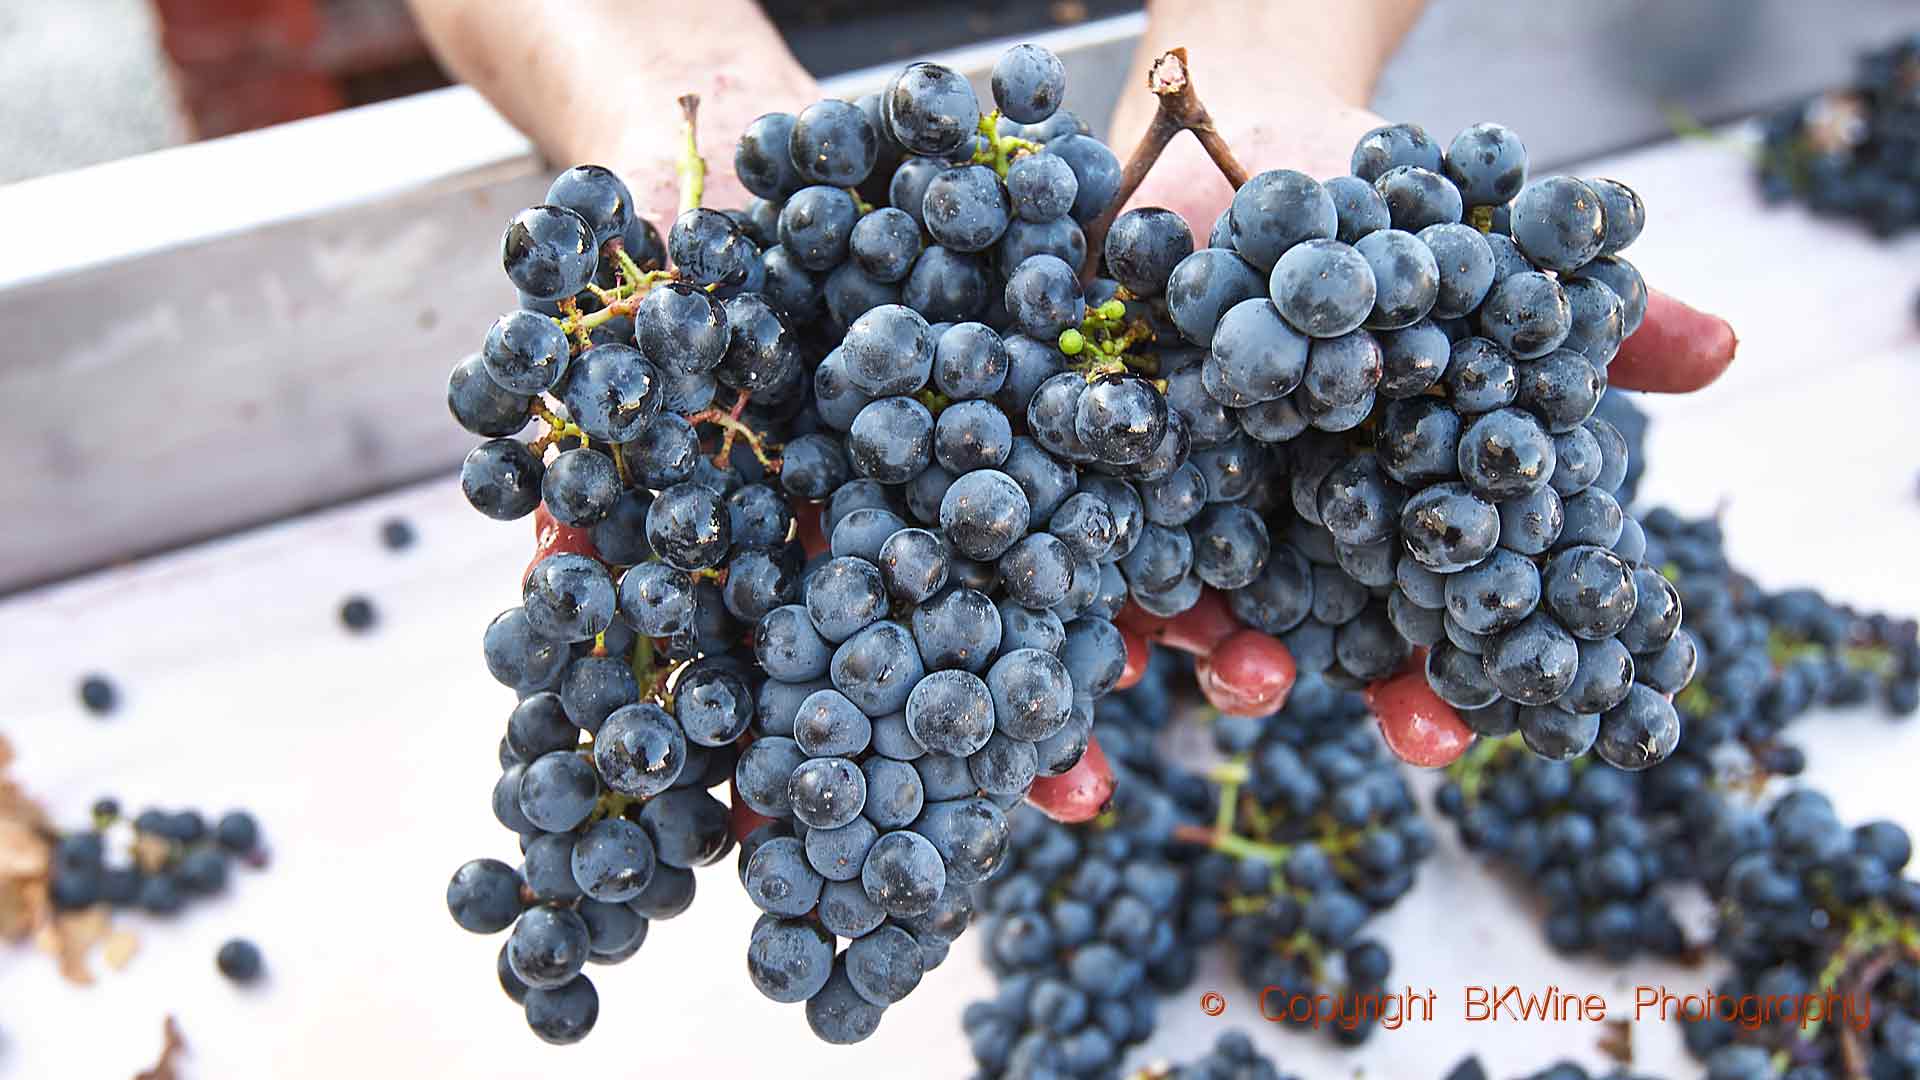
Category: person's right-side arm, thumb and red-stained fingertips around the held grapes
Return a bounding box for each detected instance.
[1052,0,1736,765]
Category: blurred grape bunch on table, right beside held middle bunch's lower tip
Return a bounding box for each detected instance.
[962,734,1198,1078]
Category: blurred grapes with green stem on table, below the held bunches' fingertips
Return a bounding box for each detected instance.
[962,653,1432,1078]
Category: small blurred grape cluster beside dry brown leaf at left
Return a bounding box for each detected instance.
[48,799,265,915]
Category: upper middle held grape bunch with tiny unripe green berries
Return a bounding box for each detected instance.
[735,46,1290,621]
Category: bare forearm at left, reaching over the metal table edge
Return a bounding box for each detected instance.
[413,0,818,225]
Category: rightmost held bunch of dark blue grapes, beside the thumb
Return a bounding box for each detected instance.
[1167,123,1692,769]
